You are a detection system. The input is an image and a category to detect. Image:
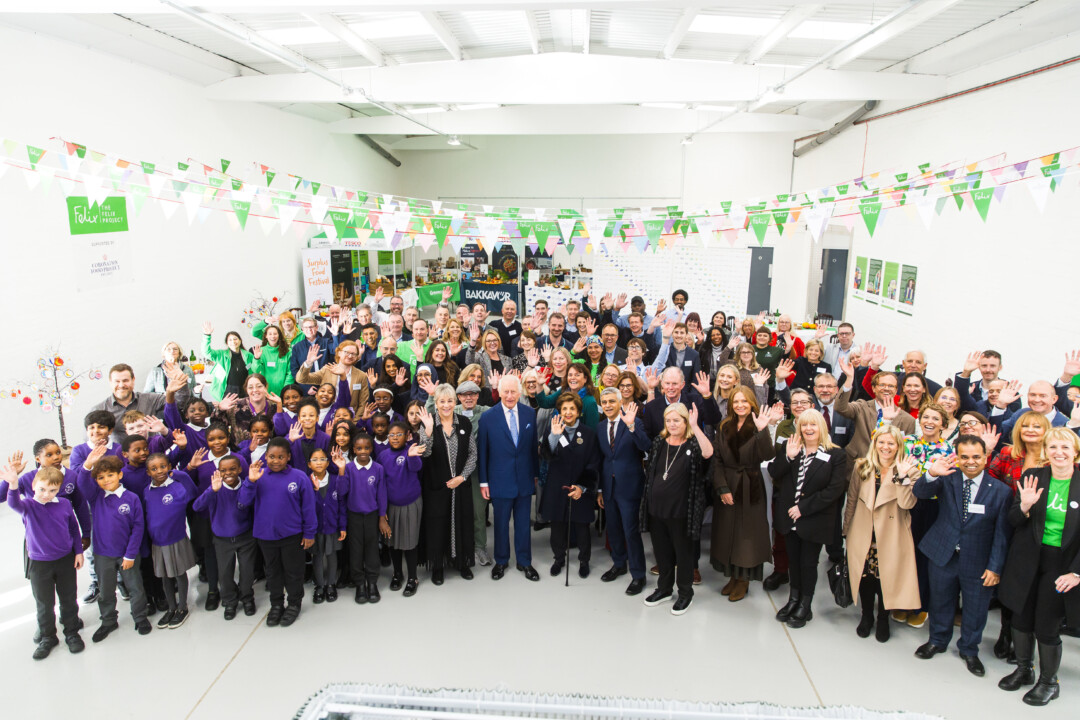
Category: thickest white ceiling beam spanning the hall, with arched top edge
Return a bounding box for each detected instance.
[206,53,946,105]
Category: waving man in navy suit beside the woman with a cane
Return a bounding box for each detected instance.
[596,388,650,595]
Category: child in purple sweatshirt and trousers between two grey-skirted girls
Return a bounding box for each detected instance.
[333,434,390,604]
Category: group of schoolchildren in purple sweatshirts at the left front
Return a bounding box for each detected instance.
[0,379,430,660]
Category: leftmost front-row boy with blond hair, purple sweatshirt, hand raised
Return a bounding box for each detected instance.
[0,464,85,660]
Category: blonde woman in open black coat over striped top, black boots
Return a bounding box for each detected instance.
[769,410,848,628]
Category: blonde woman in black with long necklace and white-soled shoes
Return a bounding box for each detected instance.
[638,403,713,615]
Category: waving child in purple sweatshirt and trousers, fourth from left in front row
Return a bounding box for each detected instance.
[194,455,259,620]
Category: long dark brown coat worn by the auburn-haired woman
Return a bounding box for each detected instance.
[710,427,773,571]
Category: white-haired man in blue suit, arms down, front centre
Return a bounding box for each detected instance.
[476,375,540,581]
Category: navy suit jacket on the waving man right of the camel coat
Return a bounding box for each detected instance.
[913,471,1013,578]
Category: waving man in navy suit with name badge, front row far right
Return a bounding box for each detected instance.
[914,435,1013,677]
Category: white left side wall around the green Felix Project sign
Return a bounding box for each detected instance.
[0,27,401,457]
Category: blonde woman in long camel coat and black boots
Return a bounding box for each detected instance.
[843,425,921,642]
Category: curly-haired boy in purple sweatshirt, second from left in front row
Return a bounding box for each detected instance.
[79,445,152,642]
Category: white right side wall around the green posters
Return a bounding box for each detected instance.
[795,60,1080,383]
